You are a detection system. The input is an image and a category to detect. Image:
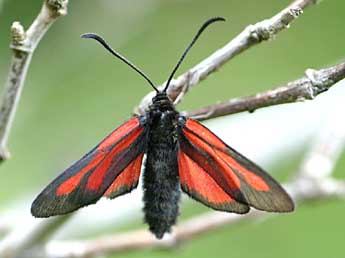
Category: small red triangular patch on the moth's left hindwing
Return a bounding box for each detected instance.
[104,154,144,196]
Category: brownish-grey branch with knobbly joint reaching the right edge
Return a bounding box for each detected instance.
[183,63,345,120]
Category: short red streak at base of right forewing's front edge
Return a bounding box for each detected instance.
[186,119,227,149]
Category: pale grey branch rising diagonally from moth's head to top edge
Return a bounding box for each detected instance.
[134,0,317,114]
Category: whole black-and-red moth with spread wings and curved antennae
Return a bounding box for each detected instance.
[31,17,294,239]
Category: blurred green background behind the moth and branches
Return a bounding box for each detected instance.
[0,0,345,258]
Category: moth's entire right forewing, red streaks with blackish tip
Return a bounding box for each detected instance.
[178,117,294,212]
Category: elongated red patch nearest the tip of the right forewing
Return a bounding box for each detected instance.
[215,150,270,192]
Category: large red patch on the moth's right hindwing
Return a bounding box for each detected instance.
[178,151,234,204]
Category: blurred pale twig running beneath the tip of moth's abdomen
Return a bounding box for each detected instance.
[43,211,262,258]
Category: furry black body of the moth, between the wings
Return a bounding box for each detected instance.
[143,112,180,239]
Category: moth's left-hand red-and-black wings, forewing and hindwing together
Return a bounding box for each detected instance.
[31,117,147,217]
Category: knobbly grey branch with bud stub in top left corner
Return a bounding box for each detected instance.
[0,0,68,162]
